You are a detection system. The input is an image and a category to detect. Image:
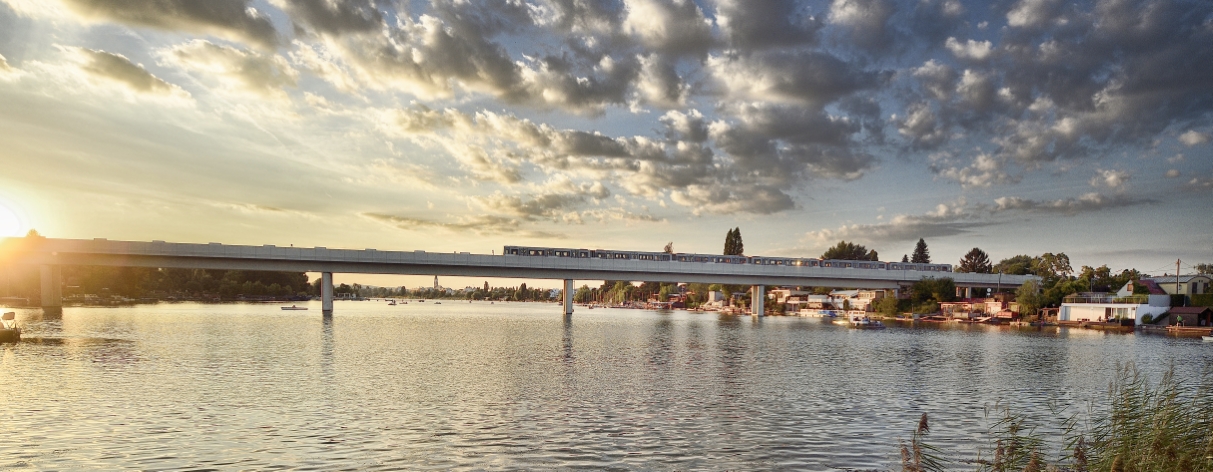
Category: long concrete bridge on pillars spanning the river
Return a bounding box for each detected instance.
[0,238,1036,314]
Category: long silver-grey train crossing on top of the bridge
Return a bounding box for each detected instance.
[501,246,952,272]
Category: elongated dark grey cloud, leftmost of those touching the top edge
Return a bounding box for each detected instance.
[61,0,279,49]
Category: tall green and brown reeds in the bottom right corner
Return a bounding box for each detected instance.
[900,364,1213,472]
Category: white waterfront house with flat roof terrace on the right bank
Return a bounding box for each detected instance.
[1058,283,1171,324]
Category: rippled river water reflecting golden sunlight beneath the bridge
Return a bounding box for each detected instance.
[0,301,1213,471]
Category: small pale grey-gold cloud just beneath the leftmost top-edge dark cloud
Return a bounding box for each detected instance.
[161,39,298,97]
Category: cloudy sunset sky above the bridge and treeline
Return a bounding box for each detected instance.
[0,0,1213,286]
